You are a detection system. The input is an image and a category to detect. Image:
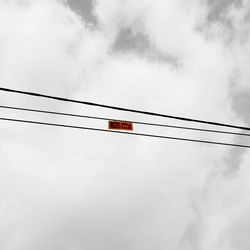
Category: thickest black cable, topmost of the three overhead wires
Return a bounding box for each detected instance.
[0,87,250,131]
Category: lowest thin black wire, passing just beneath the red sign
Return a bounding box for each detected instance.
[0,117,250,148]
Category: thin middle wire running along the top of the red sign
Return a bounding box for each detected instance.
[0,105,250,136]
